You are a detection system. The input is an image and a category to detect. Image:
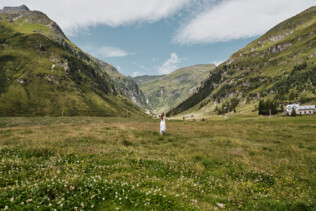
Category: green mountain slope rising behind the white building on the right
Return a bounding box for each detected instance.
[168,7,316,115]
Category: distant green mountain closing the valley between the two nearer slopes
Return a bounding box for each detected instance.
[133,64,215,113]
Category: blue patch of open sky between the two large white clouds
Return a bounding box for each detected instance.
[69,20,255,76]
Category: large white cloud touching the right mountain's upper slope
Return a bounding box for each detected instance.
[173,0,315,44]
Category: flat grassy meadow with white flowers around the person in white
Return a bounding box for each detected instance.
[0,116,316,210]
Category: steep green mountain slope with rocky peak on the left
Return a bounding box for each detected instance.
[0,6,143,116]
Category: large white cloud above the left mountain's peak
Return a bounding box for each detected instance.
[0,0,192,35]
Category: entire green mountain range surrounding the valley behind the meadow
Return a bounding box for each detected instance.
[0,5,316,116]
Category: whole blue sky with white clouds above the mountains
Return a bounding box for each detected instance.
[0,0,316,76]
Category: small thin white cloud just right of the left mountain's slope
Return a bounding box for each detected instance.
[82,46,132,58]
